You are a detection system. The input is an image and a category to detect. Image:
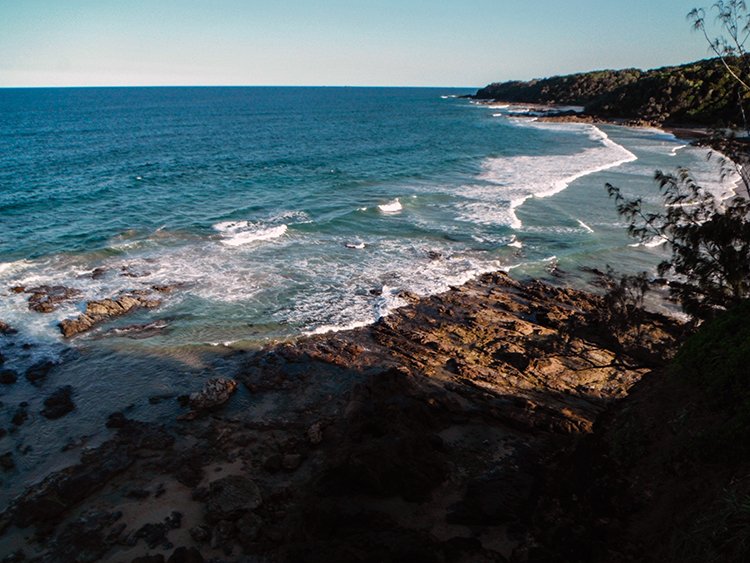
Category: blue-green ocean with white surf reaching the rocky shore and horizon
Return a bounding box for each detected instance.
[0,87,732,496]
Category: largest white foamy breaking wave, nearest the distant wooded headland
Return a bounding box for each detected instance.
[459,124,637,229]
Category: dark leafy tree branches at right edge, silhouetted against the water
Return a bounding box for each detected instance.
[607,169,750,319]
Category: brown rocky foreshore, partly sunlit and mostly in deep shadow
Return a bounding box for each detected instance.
[0,273,680,563]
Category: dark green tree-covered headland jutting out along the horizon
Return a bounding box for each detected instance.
[475,58,750,126]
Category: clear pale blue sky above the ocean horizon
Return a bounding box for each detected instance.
[0,0,724,86]
